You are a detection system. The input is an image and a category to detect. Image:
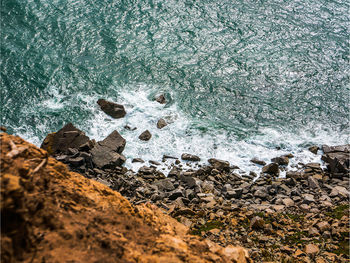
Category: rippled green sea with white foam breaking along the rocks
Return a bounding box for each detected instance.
[0,0,350,175]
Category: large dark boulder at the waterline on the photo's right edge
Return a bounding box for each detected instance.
[322,144,350,175]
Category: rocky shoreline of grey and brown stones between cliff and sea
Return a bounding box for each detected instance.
[3,96,350,262]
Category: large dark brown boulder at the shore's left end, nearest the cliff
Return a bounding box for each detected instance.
[40,123,90,155]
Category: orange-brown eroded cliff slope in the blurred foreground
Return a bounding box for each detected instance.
[0,133,248,263]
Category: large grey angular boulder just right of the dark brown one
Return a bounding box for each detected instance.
[91,131,126,169]
